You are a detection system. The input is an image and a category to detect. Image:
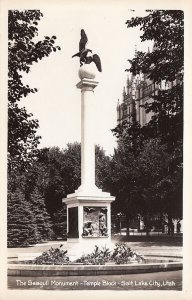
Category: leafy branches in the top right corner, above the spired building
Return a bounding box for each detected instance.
[126,10,184,82]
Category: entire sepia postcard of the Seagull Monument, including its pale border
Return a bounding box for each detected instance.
[2,1,190,299]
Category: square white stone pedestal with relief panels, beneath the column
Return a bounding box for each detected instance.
[63,187,115,259]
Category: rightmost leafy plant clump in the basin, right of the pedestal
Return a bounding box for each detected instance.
[111,243,143,265]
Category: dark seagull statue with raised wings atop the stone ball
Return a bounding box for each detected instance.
[72,29,102,72]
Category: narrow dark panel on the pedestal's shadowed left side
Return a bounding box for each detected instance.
[67,207,79,238]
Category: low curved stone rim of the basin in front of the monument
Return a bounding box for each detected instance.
[8,256,183,277]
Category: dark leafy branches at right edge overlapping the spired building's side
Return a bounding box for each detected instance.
[142,83,183,152]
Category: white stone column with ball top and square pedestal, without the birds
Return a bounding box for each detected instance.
[63,64,115,257]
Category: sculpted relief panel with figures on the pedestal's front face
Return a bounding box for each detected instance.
[82,206,108,237]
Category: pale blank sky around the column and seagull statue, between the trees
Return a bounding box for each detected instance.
[21,3,152,155]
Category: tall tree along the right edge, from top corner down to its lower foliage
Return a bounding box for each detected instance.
[126,10,184,224]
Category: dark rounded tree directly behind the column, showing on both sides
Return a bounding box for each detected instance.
[23,142,110,237]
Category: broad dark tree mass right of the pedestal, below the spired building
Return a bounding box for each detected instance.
[110,117,178,234]
